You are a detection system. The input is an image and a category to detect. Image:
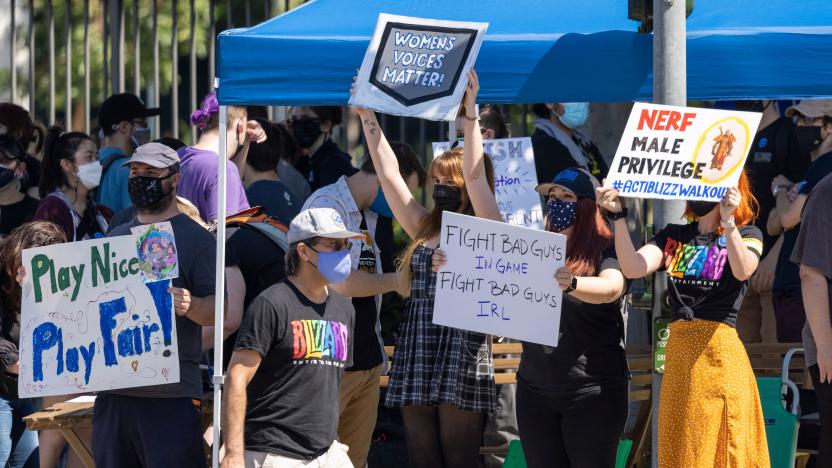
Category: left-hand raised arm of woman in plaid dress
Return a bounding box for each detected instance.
[353,107,429,238]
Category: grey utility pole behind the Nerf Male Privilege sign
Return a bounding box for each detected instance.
[651,0,687,467]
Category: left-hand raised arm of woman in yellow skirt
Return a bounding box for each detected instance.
[595,187,662,279]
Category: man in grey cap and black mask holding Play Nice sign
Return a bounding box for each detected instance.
[92,143,221,467]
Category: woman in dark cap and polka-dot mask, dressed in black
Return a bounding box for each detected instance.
[517,167,629,468]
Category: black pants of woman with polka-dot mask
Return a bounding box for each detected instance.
[517,383,628,468]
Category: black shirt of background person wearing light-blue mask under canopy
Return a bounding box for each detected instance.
[531,129,609,184]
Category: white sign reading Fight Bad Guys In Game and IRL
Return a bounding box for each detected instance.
[433,211,566,346]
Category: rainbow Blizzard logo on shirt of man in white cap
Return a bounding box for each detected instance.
[292,320,349,367]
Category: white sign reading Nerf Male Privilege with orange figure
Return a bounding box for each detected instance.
[604,103,762,201]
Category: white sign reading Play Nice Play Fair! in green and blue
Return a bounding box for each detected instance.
[18,236,179,397]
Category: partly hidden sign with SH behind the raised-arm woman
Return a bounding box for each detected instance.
[433,137,543,229]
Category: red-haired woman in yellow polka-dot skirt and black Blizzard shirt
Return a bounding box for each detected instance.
[597,172,769,467]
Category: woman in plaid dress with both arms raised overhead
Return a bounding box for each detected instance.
[356,71,502,467]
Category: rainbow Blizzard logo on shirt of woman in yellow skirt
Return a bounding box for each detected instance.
[664,237,728,286]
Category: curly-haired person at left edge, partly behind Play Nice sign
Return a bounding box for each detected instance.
[0,221,66,468]
